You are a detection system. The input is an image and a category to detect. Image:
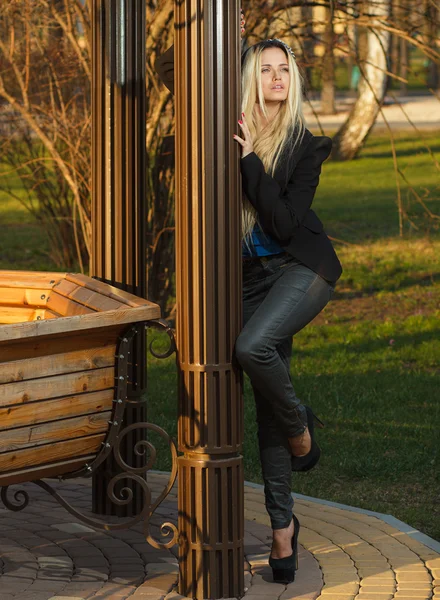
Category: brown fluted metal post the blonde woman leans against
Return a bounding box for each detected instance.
[175,0,244,599]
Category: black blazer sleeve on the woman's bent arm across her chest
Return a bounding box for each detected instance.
[241,136,332,243]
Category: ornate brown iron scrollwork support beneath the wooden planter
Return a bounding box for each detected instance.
[0,319,179,549]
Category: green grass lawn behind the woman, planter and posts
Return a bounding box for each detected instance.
[0,134,440,539]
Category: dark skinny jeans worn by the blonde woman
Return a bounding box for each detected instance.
[235,254,334,529]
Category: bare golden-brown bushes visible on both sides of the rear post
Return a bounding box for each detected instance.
[0,0,174,314]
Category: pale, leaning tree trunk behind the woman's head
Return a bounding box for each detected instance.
[333,0,391,160]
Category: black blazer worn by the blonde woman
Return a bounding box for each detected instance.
[155,46,342,282]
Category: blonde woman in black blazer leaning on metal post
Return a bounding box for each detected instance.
[155,35,342,583]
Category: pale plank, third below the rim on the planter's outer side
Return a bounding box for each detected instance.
[0,368,115,406]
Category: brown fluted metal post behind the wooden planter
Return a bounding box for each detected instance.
[90,0,146,516]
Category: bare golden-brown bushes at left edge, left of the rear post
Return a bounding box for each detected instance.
[0,0,90,270]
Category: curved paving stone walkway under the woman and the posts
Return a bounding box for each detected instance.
[0,473,440,600]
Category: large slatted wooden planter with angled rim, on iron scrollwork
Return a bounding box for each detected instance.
[0,271,160,487]
